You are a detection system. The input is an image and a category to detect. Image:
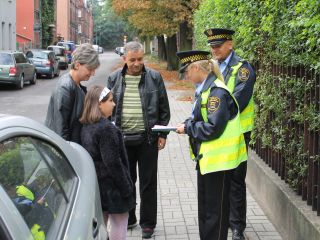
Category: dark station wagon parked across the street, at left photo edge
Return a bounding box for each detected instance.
[0,51,37,89]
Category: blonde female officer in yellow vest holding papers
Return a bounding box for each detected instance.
[177,51,247,240]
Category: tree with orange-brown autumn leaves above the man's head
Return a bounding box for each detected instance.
[112,0,199,69]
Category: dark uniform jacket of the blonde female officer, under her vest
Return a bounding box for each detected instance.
[185,74,238,156]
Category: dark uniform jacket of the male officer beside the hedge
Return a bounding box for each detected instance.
[222,52,256,112]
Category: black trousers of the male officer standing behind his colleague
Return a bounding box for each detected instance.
[229,132,251,232]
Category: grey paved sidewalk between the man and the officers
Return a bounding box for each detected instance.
[127,86,282,240]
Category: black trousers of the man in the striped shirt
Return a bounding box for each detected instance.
[126,141,158,228]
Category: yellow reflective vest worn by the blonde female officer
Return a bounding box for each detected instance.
[195,79,248,175]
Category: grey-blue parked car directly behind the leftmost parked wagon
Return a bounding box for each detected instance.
[26,49,60,78]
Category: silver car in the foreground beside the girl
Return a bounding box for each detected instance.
[0,114,108,240]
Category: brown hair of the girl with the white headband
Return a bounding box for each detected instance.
[79,85,112,124]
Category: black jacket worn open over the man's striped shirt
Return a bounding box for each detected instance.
[107,65,170,142]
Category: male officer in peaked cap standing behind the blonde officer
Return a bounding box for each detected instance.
[204,28,256,240]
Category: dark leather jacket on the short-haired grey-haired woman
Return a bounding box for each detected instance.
[45,73,86,143]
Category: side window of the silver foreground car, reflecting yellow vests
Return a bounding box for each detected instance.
[0,137,77,239]
